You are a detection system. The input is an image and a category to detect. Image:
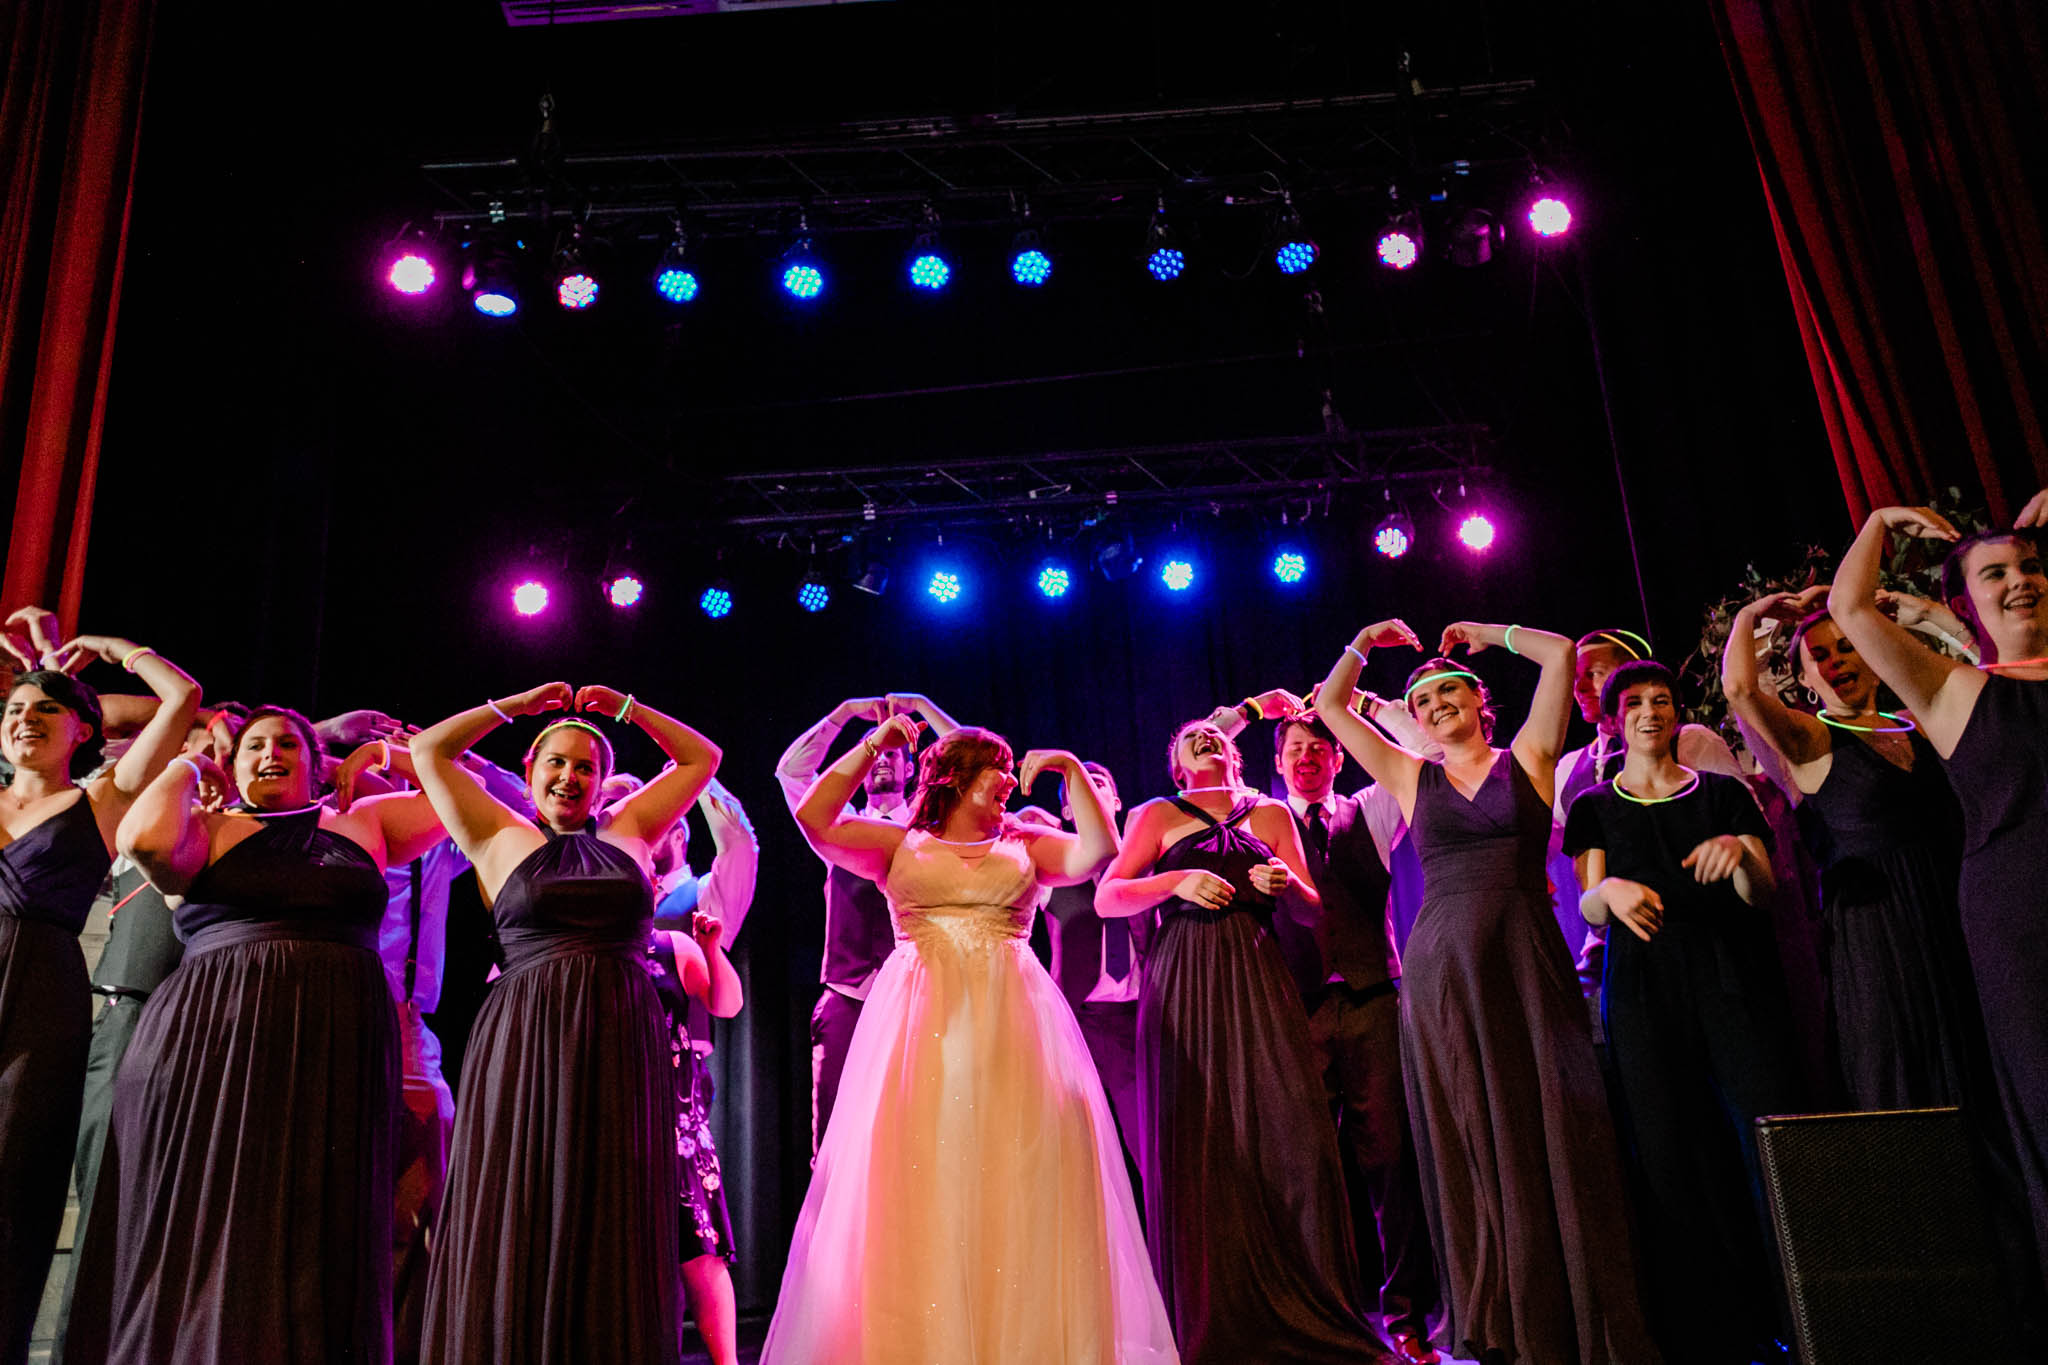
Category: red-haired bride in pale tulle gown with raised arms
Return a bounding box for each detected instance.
[762,716,1180,1365]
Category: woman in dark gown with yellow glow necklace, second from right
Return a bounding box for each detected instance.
[1720,583,1989,1109]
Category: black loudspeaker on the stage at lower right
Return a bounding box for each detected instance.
[1757,1109,2021,1365]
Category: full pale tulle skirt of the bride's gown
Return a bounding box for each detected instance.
[762,927,1178,1365]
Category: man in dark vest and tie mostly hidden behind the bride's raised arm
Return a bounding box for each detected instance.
[1044,763,1145,1209]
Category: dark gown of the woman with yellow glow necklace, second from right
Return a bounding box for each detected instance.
[1798,733,1991,1109]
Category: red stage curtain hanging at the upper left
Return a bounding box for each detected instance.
[0,0,156,628]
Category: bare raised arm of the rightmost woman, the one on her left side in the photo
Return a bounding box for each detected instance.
[1827,508,1985,757]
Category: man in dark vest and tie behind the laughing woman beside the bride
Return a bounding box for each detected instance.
[1274,712,1440,1363]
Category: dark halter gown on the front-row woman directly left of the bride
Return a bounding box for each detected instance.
[420,831,678,1365]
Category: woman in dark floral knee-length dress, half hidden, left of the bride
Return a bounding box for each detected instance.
[647,908,741,1365]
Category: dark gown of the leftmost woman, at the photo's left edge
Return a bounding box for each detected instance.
[0,792,113,1365]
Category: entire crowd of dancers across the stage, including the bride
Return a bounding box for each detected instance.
[0,491,2048,1365]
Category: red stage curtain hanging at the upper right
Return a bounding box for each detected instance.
[1710,0,2048,520]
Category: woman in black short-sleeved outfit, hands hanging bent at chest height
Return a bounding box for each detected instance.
[1565,659,1802,1365]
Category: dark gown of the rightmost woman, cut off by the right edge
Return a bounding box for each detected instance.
[1948,673,2048,1281]
